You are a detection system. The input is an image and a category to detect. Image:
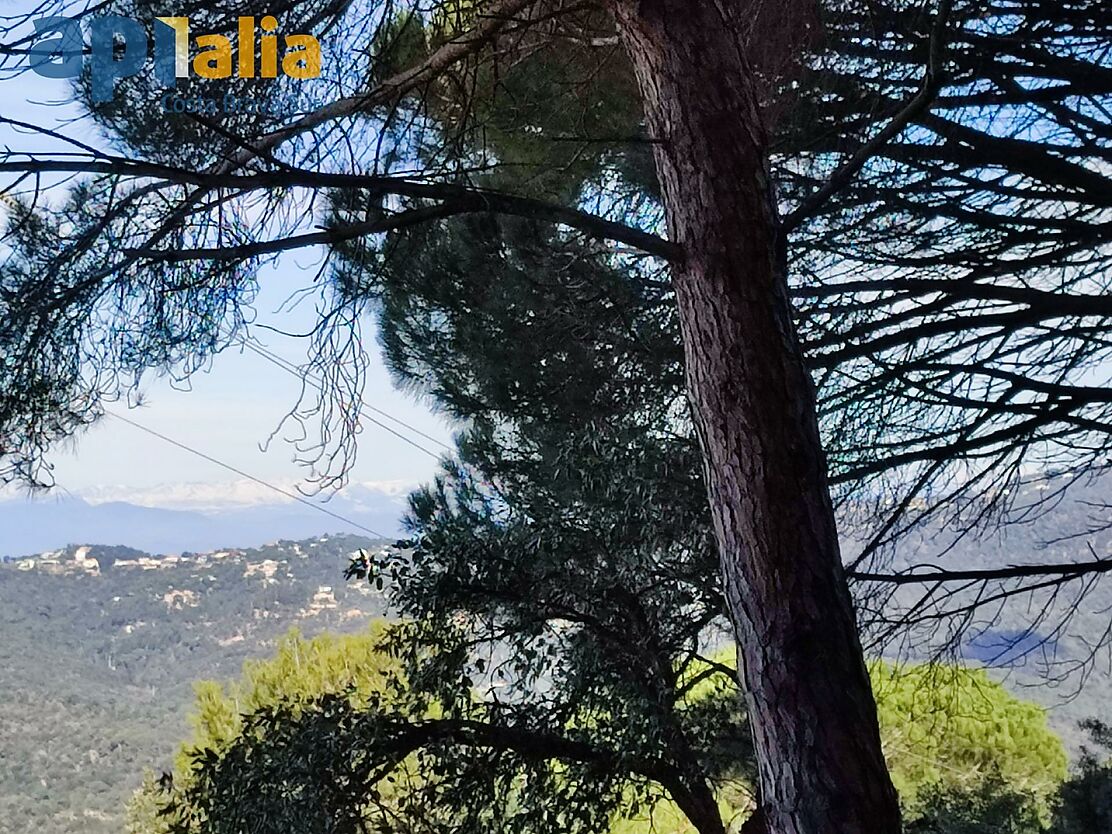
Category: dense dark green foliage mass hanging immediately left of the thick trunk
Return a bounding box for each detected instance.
[364,218,747,822]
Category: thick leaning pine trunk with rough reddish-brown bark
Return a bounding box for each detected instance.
[612,0,900,834]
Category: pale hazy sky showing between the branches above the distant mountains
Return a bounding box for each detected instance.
[0,40,450,493]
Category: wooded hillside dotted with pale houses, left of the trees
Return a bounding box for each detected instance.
[0,536,383,834]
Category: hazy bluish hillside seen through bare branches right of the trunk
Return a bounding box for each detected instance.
[862,476,1112,754]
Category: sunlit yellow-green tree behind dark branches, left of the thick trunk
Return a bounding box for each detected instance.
[129,625,752,834]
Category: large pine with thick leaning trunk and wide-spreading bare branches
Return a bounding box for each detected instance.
[0,0,1112,834]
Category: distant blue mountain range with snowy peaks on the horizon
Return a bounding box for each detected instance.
[0,481,406,557]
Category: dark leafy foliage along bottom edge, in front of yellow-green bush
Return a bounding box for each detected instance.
[171,697,649,834]
